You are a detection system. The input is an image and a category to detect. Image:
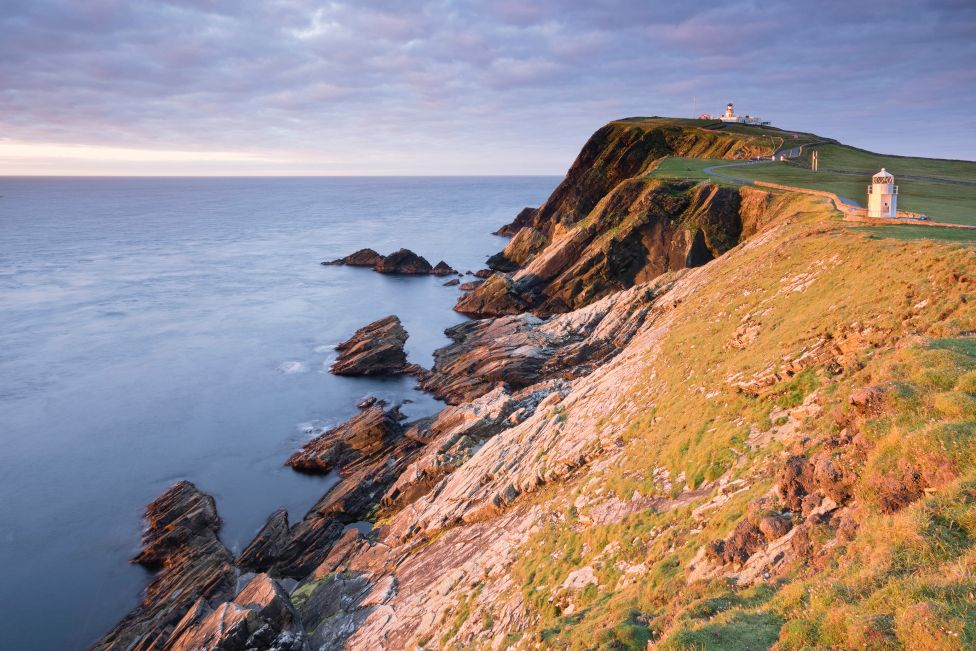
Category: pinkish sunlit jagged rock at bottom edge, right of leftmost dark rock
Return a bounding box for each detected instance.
[166,574,307,651]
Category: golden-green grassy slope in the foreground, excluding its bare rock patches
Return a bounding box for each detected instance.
[496,199,976,649]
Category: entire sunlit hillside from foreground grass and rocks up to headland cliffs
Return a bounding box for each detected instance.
[97,118,976,650]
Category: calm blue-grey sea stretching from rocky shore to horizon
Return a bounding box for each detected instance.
[0,177,558,650]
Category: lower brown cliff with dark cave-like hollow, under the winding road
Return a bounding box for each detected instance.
[455,178,756,317]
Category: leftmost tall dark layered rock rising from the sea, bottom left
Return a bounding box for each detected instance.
[92,481,237,651]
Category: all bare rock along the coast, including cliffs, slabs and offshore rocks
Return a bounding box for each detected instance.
[94,118,976,650]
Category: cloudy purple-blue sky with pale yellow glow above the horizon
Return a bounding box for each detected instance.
[0,0,976,175]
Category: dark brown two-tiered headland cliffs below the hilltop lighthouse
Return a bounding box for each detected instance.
[464,121,768,316]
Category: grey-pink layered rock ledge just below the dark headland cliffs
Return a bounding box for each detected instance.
[419,276,673,405]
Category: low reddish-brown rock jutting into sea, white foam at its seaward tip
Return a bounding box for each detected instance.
[288,401,403,473]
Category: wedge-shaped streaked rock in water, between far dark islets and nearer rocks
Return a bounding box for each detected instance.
[332,315,407,375]
